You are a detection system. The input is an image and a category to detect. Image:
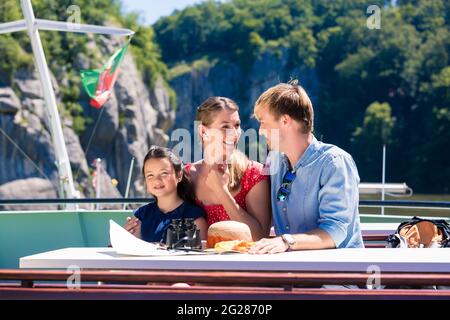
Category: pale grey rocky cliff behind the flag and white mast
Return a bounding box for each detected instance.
[0,38,175,208]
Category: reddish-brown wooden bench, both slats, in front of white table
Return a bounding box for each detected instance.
[0,269,450,299]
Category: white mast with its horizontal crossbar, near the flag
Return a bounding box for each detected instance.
[0,0,134,198]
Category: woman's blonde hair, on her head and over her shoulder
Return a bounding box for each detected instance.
[196,97,249,190]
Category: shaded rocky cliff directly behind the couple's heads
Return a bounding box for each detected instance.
[170,50,319,139]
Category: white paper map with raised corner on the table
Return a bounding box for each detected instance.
[109,220,185,256]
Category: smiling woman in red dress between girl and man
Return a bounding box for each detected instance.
[185,97,271,240]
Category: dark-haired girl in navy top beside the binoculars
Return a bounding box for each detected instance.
[125,146,207,242]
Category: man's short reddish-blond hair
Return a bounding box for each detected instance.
[254,80,314,133]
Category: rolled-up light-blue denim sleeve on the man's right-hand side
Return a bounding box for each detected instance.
[318,155,359,248]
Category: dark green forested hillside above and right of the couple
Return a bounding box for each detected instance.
[154,0,450,192]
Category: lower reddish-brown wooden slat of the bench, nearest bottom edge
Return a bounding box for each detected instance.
[0,286,450,303]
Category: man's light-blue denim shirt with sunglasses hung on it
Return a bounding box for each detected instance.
[266,137,364,248]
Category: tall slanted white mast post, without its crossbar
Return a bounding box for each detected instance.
[20,0,77,198]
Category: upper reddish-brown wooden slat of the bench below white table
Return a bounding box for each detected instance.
[0,269,450,287]
